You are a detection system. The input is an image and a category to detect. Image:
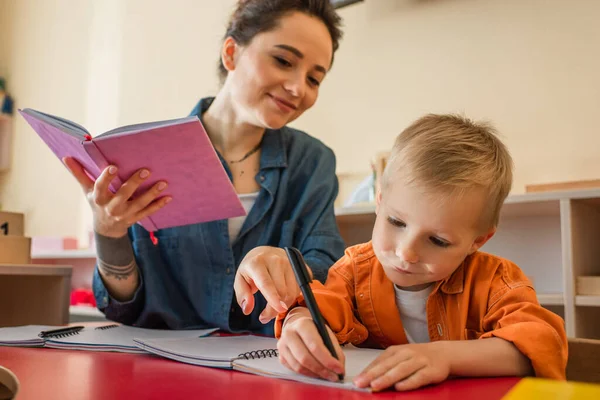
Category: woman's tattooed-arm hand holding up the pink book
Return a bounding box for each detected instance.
[63,157,171,238]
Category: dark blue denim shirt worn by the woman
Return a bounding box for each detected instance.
[93,98,344,335]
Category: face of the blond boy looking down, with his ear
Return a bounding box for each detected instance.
[373,180,495,290]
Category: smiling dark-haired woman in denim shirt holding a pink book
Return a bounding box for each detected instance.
[65,0,344,335]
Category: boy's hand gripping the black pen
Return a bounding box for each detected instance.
[277,307,345,382]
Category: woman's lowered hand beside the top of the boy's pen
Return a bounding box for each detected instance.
[233,246,310,324]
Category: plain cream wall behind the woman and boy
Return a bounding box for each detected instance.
[0,0,600,244]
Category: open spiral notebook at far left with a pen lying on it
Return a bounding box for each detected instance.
[0,323,217,353]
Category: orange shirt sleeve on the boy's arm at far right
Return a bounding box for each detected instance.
[480,282,568,380]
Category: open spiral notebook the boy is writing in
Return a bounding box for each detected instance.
[134,336,382,391]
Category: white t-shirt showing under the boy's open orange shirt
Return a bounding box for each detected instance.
[394,285,433,343]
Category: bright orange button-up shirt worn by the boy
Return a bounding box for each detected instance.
[275,242,567,380]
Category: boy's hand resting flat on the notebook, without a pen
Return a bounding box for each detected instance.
[354,342,451,391]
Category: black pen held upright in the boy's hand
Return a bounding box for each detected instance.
[284,247,344,381]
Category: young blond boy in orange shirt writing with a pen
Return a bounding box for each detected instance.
[275,115,567,390]
